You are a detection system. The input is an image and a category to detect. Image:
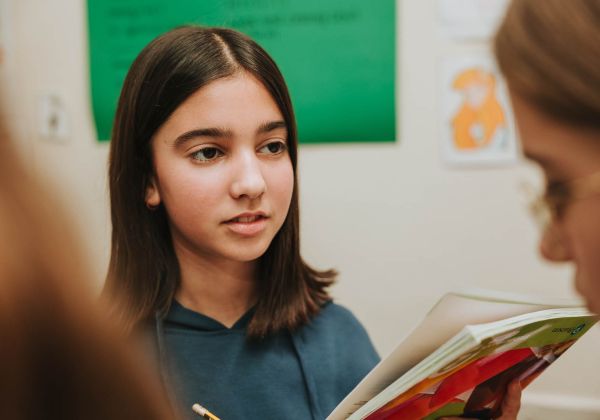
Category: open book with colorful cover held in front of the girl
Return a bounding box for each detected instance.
[327,291,596,420]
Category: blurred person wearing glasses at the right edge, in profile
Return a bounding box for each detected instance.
[495,0,600,313]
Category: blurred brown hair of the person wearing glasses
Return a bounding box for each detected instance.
[495,0,600,128]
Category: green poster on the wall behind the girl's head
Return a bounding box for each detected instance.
[88,0,396,143]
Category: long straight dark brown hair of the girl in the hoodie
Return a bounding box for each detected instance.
[106,26,335,337]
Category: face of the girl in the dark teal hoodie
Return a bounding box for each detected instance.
[146,73,294,262]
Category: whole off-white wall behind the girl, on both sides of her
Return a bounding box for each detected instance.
[1,0,600,418]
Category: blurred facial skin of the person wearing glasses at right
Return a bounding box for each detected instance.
[511,92,600,313]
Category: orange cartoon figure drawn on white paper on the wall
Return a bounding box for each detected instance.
[452,68,507,151]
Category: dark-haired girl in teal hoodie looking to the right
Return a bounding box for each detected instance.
[107,27,379,420]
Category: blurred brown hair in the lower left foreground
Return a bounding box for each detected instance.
[0,128,175,420]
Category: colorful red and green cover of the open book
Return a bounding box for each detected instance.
[366,317,595,420]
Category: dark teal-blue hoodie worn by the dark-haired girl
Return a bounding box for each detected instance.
[158,302,379,420]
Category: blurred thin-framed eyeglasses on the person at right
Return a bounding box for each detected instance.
[527,172,600,228]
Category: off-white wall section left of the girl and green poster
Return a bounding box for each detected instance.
[3,0,110,287]
